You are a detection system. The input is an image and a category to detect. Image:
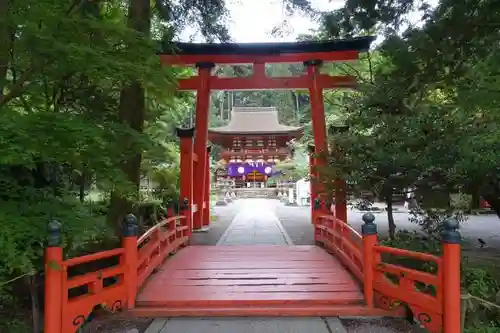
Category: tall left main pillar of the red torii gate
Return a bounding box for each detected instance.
[193,63,214,230]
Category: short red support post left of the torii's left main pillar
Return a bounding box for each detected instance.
[177,128,195,236]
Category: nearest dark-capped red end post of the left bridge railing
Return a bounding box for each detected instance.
[43,220,63,333]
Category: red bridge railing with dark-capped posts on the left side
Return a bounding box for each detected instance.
[44,210,189,333]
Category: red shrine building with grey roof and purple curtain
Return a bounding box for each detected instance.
[208,107,303,188]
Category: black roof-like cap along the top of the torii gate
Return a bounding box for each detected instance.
[160,36,375,55]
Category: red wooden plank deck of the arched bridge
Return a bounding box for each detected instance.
[133,245,390,316]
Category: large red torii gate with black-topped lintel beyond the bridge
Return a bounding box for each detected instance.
[160,37,374,230]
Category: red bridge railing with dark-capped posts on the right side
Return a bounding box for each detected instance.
[315,213,461,333]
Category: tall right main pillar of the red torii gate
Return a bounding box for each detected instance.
[304,60,328,213]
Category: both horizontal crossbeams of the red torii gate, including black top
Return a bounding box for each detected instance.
[160,36,374,90]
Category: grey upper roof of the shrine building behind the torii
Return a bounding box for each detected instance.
[208,107,302,137]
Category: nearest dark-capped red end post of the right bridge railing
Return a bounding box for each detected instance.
[441,219,462,333]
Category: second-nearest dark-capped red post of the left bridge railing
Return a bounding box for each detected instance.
[122,214,139,309]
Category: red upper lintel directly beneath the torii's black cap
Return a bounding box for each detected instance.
[160,51,359,65]
